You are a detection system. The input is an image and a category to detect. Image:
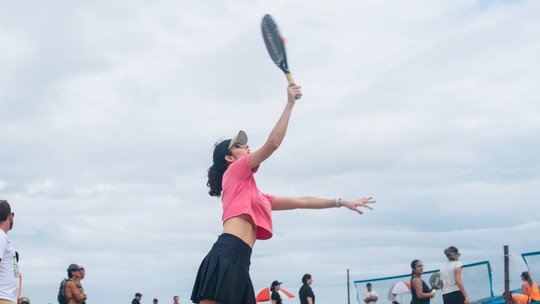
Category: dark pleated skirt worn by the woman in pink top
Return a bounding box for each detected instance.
[191,233,256,304]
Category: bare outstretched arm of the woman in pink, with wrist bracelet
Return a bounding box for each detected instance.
[272,196,375,214]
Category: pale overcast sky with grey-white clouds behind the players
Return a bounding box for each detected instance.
[0,0,540,304]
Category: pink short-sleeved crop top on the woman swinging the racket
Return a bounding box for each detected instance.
[221,154,274,240]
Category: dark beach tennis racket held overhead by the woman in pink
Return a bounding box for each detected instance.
[261,14,302,99]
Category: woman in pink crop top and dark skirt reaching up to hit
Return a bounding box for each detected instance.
[191,84,374,304]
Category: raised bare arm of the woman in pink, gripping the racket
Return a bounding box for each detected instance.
[250,83,302,168]
